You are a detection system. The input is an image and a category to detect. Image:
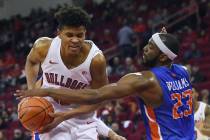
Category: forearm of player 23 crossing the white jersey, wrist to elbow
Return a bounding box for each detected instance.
[46,84,131,104]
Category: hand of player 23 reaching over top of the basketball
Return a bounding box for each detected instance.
[14,89,48,100]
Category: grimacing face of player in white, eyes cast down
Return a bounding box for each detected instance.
[58,26,86,55]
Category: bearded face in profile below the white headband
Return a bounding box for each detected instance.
[143,39,160,67]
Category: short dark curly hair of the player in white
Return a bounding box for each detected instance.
[55,6,91,28]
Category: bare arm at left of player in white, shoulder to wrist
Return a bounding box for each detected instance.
[25,37,51,89]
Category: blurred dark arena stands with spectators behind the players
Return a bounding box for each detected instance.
[0,0,210,140]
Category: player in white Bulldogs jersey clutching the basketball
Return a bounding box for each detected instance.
[25,7,124,140]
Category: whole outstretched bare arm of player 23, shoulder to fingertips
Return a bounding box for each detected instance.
[15,72,155,104]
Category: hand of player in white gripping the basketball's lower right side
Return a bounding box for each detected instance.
[39,112,64,133]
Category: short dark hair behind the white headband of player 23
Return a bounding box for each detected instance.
[159,33,180,55]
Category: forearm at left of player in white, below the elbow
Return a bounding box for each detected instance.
[25,61,39,89]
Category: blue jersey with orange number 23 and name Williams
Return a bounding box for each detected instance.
[138,64,195,140]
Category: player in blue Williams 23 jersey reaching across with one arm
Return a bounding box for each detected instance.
[16,30,194,140]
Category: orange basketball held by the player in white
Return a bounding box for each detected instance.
[18,97,54,131]
